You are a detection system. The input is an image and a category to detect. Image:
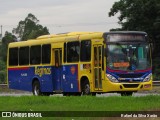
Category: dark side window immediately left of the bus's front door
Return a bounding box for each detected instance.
[80,40,91,61]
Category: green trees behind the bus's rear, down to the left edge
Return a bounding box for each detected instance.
[0,13,49,83]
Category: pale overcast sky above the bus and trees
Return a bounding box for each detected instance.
[0,0,120,34]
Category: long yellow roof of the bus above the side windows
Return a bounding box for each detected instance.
[9,32,103,47]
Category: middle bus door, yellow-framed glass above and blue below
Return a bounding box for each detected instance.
[53,48,62,91]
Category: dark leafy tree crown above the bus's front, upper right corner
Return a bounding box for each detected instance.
[109,0,160,42]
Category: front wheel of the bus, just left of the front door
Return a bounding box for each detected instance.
[82,81,91,95]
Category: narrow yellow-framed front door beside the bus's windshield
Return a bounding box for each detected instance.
[94,45,103,90]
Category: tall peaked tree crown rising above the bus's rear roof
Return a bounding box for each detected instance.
[12,13,49,40]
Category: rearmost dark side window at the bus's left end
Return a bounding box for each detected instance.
[9,48,18,66]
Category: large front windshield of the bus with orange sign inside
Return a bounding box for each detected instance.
[106,44,151,71]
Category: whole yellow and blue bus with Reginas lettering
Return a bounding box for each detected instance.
[7,31,152,95]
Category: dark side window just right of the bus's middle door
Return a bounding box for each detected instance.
[67,42,80,62]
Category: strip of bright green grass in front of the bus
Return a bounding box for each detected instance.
[0,96,160,111]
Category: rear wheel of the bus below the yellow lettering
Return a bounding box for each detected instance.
[32,81,42,96]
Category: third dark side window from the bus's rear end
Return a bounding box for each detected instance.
[30,45,41,65]
